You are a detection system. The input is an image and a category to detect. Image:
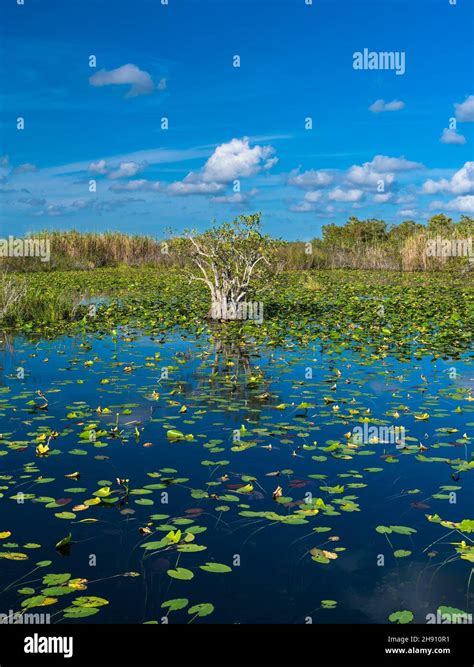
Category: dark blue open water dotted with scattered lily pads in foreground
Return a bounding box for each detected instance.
[0,332,474,623]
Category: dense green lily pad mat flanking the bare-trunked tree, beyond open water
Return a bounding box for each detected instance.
[5,267,474,358]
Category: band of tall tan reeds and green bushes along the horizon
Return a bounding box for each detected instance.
[0,214,474,272]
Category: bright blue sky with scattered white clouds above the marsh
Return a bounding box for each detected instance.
[0,0,474,240]
